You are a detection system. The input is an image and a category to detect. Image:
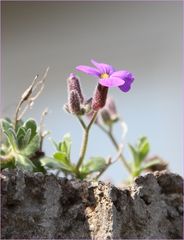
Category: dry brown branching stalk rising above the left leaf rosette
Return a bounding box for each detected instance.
[14,67,49,127]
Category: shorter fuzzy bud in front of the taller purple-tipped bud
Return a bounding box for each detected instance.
[68,90,81,115]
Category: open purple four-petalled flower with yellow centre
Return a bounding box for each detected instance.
[76,60,134,92]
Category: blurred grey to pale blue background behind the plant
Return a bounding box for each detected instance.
[1,1,183,183]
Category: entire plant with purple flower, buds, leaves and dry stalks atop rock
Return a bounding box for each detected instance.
[0,60,167,179]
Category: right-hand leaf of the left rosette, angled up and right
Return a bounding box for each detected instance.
[21,134,40,157]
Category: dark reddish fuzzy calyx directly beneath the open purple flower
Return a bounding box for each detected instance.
[91,84,108,111]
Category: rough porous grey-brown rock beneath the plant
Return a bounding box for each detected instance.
[1,170,183,240]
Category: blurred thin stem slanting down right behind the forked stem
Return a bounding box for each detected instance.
[98,124,132,174]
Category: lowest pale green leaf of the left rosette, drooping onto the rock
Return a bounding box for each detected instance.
[15,154,35,171]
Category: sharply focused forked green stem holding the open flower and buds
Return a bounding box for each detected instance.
[76,112,98,172]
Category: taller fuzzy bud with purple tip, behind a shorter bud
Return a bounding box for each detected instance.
[68,73,84,103]
